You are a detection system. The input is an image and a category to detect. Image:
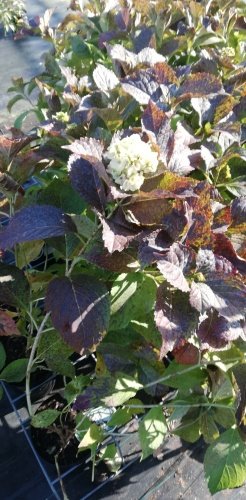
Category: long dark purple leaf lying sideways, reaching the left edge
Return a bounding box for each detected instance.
[0,205,76,250]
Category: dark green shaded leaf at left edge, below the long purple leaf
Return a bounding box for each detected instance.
[0,263,30,306]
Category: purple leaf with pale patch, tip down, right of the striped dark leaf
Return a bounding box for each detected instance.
[155,285,198,357]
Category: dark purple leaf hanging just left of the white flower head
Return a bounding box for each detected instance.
[68,154,107,212]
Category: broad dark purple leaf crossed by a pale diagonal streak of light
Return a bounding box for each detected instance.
[45,274,110,354]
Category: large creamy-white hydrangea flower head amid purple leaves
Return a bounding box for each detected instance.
[106,134,158,191]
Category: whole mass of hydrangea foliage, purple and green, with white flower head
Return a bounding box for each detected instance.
[0,0,246,493]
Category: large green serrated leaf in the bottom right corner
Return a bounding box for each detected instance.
[204,428,246,494]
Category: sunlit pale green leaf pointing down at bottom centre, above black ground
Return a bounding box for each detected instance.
[138,407,167,460]
